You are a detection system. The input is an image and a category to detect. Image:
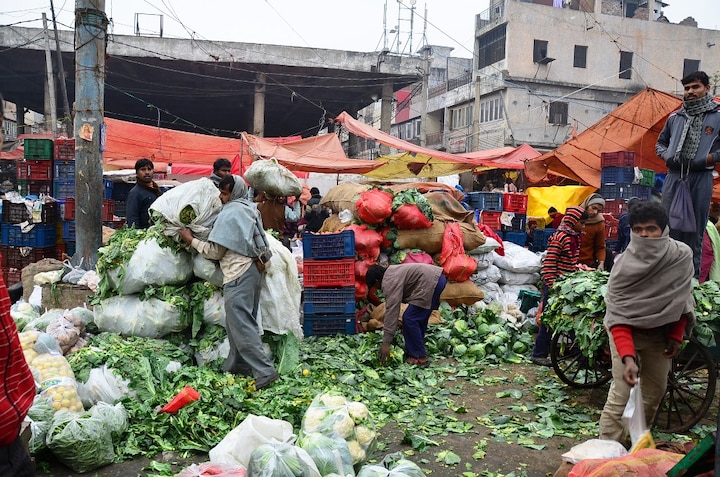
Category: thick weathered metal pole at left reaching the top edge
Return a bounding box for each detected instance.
[72,0,108,270]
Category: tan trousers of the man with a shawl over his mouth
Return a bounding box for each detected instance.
[600,327,672,445]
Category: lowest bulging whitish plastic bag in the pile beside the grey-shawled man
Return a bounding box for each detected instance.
[95,295,188,338]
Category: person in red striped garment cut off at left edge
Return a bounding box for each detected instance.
[0,95,36,477]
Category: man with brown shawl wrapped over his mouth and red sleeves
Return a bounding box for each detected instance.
[600,201,695,444]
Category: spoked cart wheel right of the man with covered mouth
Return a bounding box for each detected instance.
[653,337,717,433]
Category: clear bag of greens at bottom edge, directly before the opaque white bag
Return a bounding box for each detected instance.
[248,442,321,477]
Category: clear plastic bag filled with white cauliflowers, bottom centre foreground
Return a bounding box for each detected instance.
[301,393,377,464]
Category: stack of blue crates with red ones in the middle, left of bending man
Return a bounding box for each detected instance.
[302,230,357,336]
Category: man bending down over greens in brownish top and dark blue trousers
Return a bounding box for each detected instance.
[365,263,447,366]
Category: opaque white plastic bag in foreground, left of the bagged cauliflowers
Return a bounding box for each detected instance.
[209,414,294,467]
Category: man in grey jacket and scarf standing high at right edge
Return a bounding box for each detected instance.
[655,71,720,278]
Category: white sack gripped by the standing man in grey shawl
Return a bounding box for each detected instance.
[150,177,222,240]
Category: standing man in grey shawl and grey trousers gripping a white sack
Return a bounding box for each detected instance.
[180,175,279,389]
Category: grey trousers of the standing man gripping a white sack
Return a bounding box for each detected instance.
[223,264,275,379]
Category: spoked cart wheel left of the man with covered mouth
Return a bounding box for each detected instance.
[550,332,612,389]
